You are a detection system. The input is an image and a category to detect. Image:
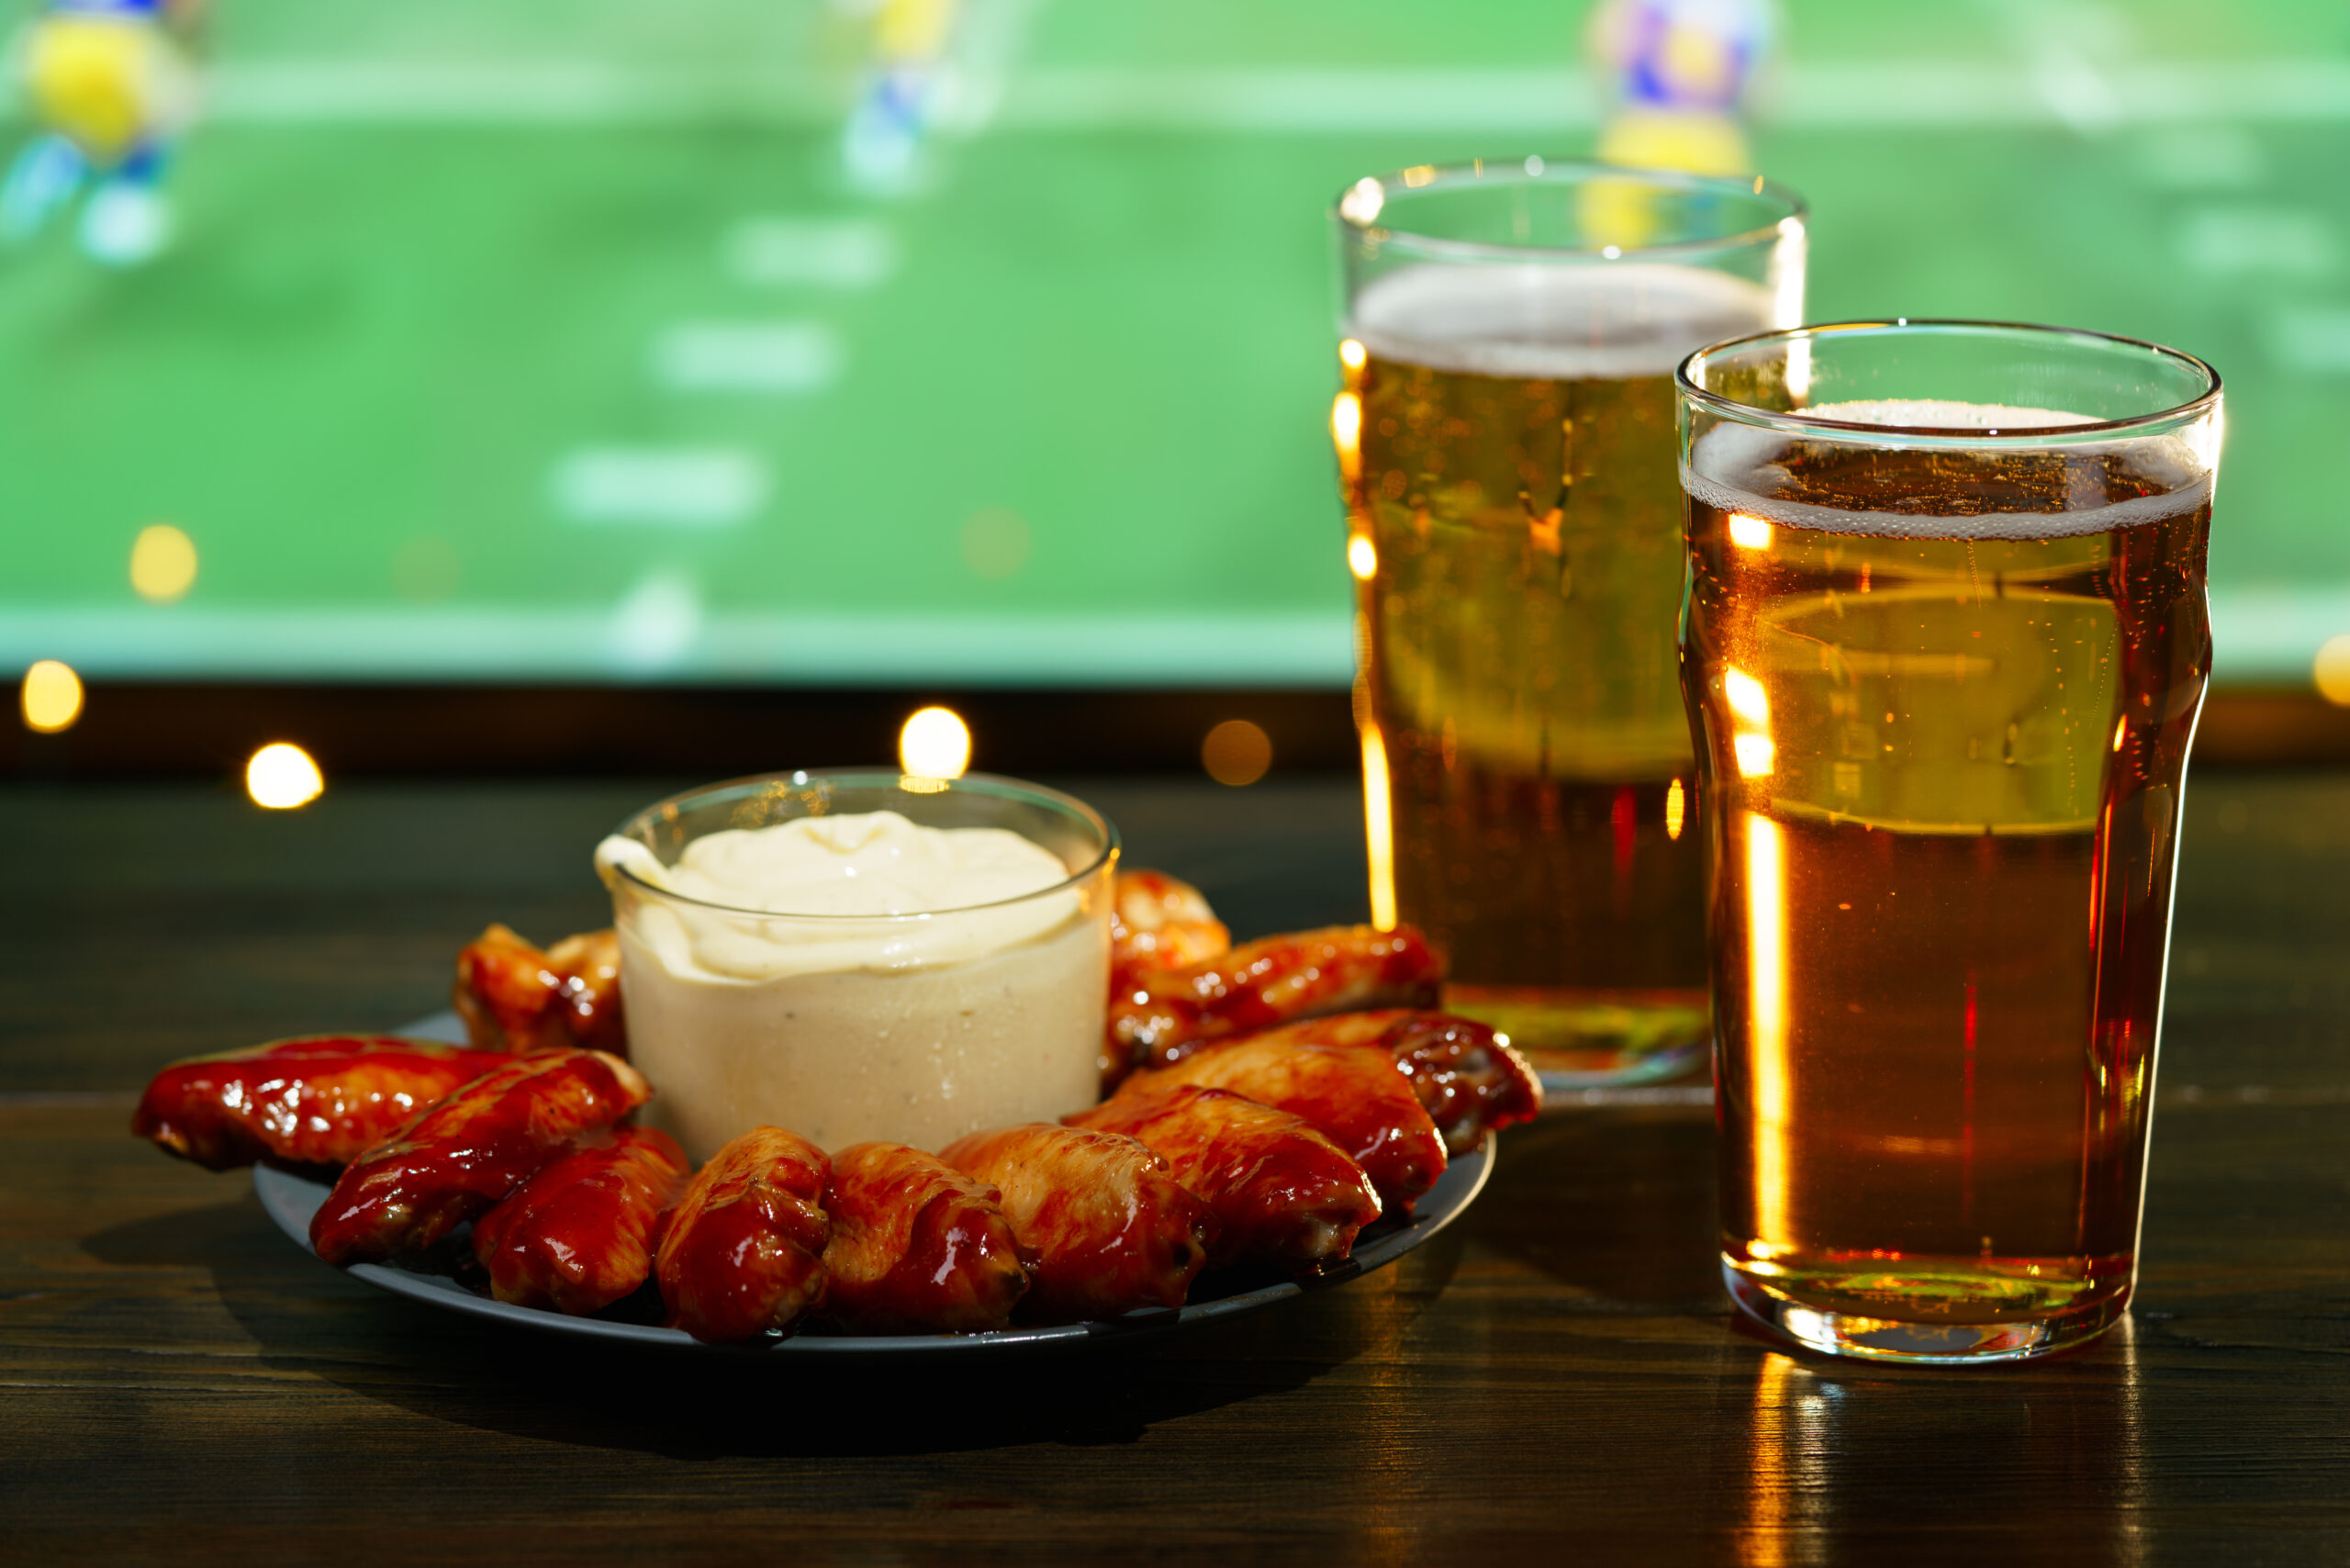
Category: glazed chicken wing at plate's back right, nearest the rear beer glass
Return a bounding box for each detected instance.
[1109,926,1445,1068]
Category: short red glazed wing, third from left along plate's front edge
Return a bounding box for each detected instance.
[473,1126,687,1316]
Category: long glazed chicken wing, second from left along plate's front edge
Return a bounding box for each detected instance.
[310,1051,654,1267]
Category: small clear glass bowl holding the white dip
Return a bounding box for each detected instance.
[597,771,1119,1161]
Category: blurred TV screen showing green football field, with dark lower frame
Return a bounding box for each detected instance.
[0,0,2350,776]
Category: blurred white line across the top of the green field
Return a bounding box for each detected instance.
[5,59,2350,134]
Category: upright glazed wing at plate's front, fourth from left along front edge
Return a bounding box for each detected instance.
[654,1126,832,1345]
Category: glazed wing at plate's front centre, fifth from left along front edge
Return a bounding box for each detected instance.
[825,1143,1029,1333]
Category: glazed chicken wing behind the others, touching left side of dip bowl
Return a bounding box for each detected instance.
[452,926,628,1056]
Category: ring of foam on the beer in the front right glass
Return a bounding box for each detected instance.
[1680,398,2211,538]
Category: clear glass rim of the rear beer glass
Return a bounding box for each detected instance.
[1330,152,1812,261]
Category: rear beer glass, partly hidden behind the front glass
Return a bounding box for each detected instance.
[1330,158,1805,1086]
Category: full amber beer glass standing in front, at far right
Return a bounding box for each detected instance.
[1678,322,2221,1361]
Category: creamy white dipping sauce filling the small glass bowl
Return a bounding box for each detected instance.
[595,811,1109,1161]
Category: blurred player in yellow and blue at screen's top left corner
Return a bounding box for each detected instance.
[0,0,197,265]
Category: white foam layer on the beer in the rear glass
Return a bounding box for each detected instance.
[1347,261,1772,381]
